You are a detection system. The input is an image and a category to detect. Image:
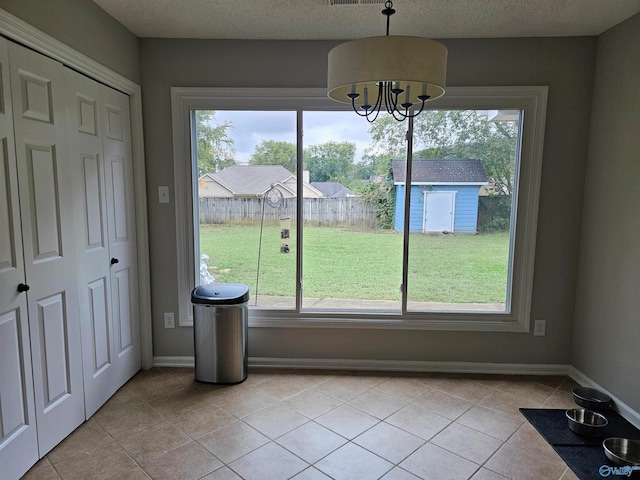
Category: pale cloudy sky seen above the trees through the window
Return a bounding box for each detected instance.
[210,110,380,164]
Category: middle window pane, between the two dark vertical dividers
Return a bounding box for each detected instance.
[302,111,402,313]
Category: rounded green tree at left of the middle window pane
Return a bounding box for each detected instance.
[304,141,356,184]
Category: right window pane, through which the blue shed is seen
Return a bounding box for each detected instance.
[402,110,521,312]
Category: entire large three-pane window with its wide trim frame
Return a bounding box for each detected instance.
[172,87,546,331]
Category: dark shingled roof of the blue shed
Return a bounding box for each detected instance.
[392,158,488,185]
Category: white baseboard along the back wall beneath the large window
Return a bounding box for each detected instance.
[153,356,570,375]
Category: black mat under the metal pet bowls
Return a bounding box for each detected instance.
[520,408,640,480]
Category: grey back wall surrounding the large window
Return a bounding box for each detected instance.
[140,37,596,364]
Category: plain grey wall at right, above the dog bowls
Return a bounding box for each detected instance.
[572,15,640,412]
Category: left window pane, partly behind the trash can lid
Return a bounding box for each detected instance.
[194,110,297,308]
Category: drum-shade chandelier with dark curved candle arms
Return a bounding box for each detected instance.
[327,0,447,122]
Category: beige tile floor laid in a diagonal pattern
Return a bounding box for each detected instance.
[24,368,577,480]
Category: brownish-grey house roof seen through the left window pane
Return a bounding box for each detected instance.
[207,165,294,195]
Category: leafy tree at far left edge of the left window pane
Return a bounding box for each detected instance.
[196,110,236,177]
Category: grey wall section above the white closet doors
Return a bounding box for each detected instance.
[0,0,140,84]
